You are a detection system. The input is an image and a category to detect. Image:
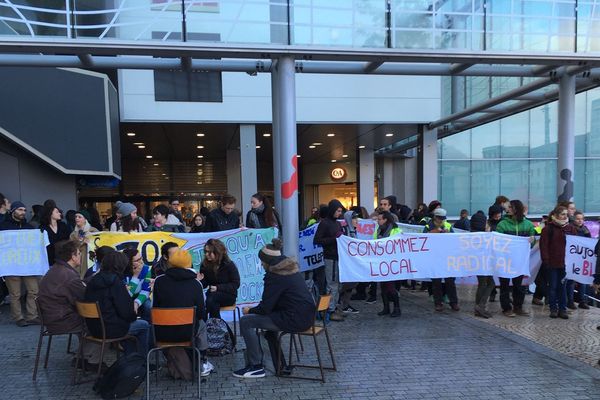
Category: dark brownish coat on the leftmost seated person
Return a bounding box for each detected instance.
[38,260,85,334]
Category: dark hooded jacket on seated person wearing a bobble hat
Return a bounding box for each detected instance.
[248,258,316,332]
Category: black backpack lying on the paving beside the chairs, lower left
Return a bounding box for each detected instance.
[94,353,146,399]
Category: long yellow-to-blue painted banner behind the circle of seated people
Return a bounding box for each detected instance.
[90,228,277,304]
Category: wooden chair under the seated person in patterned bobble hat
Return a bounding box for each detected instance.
[275,295,337,383]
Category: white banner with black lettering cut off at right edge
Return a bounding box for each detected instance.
[565,235,598,284]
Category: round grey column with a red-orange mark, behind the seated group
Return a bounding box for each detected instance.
[274,57,300,257]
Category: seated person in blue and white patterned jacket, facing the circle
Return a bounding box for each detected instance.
[123,249,152,322]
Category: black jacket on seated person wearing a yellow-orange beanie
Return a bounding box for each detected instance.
[152,267,204,342]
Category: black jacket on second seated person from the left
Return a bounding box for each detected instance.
[85,271,137,338]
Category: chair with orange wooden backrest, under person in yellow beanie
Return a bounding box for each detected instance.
[146,307,202,399]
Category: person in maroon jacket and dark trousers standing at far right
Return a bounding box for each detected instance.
[540,206,577,319]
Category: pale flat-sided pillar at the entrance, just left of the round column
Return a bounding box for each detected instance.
[238,125,258,219]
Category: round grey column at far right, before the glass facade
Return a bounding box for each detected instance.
[556,74,575,202]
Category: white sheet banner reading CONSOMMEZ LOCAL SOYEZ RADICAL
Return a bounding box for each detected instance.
[337,232,530,282]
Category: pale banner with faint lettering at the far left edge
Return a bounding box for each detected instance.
[0,229,50,276]
